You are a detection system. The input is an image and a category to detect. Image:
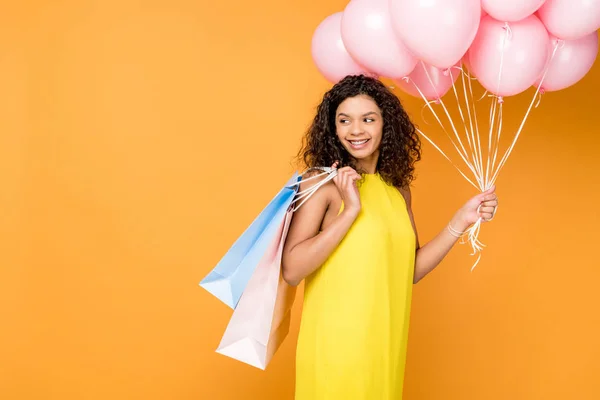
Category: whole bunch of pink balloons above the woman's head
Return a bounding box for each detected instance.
[312,0,600,100]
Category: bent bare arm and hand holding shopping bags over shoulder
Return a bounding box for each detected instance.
[281,170,360,286]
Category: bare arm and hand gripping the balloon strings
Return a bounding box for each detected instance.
[402,189,498,283]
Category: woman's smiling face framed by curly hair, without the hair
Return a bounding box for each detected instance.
[335,95,383,172]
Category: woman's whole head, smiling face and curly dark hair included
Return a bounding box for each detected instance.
[298,75,421,188]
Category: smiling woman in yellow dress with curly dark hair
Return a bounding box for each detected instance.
[282,75,498,400]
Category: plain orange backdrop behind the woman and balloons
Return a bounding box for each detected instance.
[0,0,600,400]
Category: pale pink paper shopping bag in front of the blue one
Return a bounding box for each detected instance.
[217,210,296,370]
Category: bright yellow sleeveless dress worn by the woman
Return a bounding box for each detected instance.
[296,174,416,400]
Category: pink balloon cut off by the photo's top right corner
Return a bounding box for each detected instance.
[537,0,600,40]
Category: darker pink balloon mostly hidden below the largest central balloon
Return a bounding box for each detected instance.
[395,61,461,100]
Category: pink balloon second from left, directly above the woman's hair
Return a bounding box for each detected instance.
[342,0,417,78]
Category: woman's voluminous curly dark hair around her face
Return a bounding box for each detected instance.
[298,75,421,188]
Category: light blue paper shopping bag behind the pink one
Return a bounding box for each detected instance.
[200,168,336,308]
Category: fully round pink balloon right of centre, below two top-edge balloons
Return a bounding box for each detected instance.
[469,15,550,96]
